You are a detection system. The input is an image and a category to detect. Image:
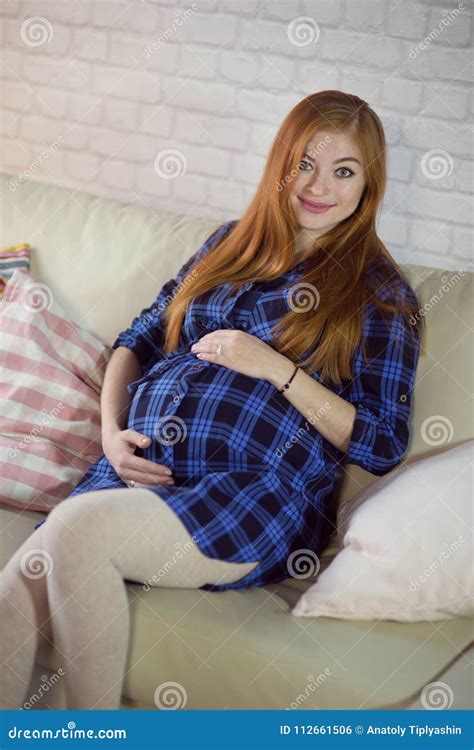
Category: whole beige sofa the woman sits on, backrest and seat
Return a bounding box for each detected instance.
[0,174,473,709]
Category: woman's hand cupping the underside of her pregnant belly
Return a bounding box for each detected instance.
[102,429,174,487]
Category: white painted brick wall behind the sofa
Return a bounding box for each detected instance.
[0,0,474,269]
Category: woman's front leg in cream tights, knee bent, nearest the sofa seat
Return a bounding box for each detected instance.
[41,488,258,709]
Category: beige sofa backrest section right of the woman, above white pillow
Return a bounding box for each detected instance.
[337,264,474,502]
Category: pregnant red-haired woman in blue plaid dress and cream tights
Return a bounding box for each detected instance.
[0,91,423,709]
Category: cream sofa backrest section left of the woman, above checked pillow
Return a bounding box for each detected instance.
[0,172,222,352]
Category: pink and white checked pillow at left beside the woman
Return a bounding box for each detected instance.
[0,270,112,512]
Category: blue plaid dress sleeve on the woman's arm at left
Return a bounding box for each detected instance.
[112,221,235,372]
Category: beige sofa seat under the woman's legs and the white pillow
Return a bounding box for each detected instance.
[0,507,472,710]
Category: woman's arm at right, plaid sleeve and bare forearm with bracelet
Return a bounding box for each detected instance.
[267,305,421,476]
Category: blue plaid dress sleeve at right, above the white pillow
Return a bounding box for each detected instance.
[340,294,420,476]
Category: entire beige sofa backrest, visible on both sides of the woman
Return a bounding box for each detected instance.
[0,173,474,508]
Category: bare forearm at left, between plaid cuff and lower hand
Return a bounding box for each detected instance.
[100,346,142,441]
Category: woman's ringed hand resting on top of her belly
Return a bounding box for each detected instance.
[191,328,282,380]
